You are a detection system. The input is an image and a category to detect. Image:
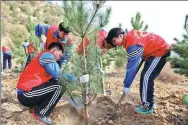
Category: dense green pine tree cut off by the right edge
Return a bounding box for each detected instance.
[169,15,188,77]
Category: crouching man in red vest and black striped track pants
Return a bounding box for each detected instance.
[17,42,64,125]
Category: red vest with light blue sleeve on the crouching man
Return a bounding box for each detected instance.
[17,50,61,91]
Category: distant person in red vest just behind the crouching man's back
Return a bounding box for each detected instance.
[25,41,36,67]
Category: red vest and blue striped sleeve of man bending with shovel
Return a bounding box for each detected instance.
[123,30,170,88]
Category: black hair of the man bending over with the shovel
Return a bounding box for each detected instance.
[106,27,125,47]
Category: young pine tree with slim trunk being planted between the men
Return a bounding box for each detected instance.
[62,0,111,124]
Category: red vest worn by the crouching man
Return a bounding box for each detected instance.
[17,50,52,91]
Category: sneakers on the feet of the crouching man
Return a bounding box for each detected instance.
[32,109,52,125]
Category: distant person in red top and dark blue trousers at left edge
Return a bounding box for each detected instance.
[2,46,12,70]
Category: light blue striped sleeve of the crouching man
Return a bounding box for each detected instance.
[39,52,61,79]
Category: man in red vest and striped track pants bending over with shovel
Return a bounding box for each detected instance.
[105,28,170,114]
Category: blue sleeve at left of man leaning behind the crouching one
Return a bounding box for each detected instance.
[35,24,50,37]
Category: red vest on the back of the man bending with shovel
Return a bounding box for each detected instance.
[123,30,170,59]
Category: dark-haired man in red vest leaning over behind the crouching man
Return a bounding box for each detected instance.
[35,22,73,67]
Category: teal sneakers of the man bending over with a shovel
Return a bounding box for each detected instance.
[135,105,154,114]
